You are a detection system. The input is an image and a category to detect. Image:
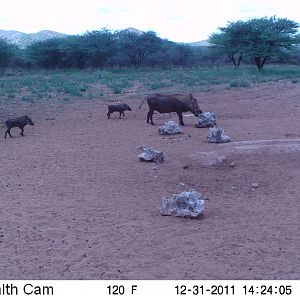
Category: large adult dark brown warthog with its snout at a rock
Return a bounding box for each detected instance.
[139,94,202,125]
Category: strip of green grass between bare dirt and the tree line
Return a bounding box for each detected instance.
[0,65,300,102]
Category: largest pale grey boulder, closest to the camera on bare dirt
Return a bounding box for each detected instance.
[159,190,204,218]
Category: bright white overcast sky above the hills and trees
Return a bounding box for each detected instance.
[0,0,300,42]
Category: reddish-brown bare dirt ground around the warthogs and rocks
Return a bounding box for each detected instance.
[0,81,300,279]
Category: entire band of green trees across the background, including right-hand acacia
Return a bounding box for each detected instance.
[0,17,300,70]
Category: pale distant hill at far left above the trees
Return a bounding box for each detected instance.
[0,29,67,48]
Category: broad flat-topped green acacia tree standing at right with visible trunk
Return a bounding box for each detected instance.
[209,16,299,71]
